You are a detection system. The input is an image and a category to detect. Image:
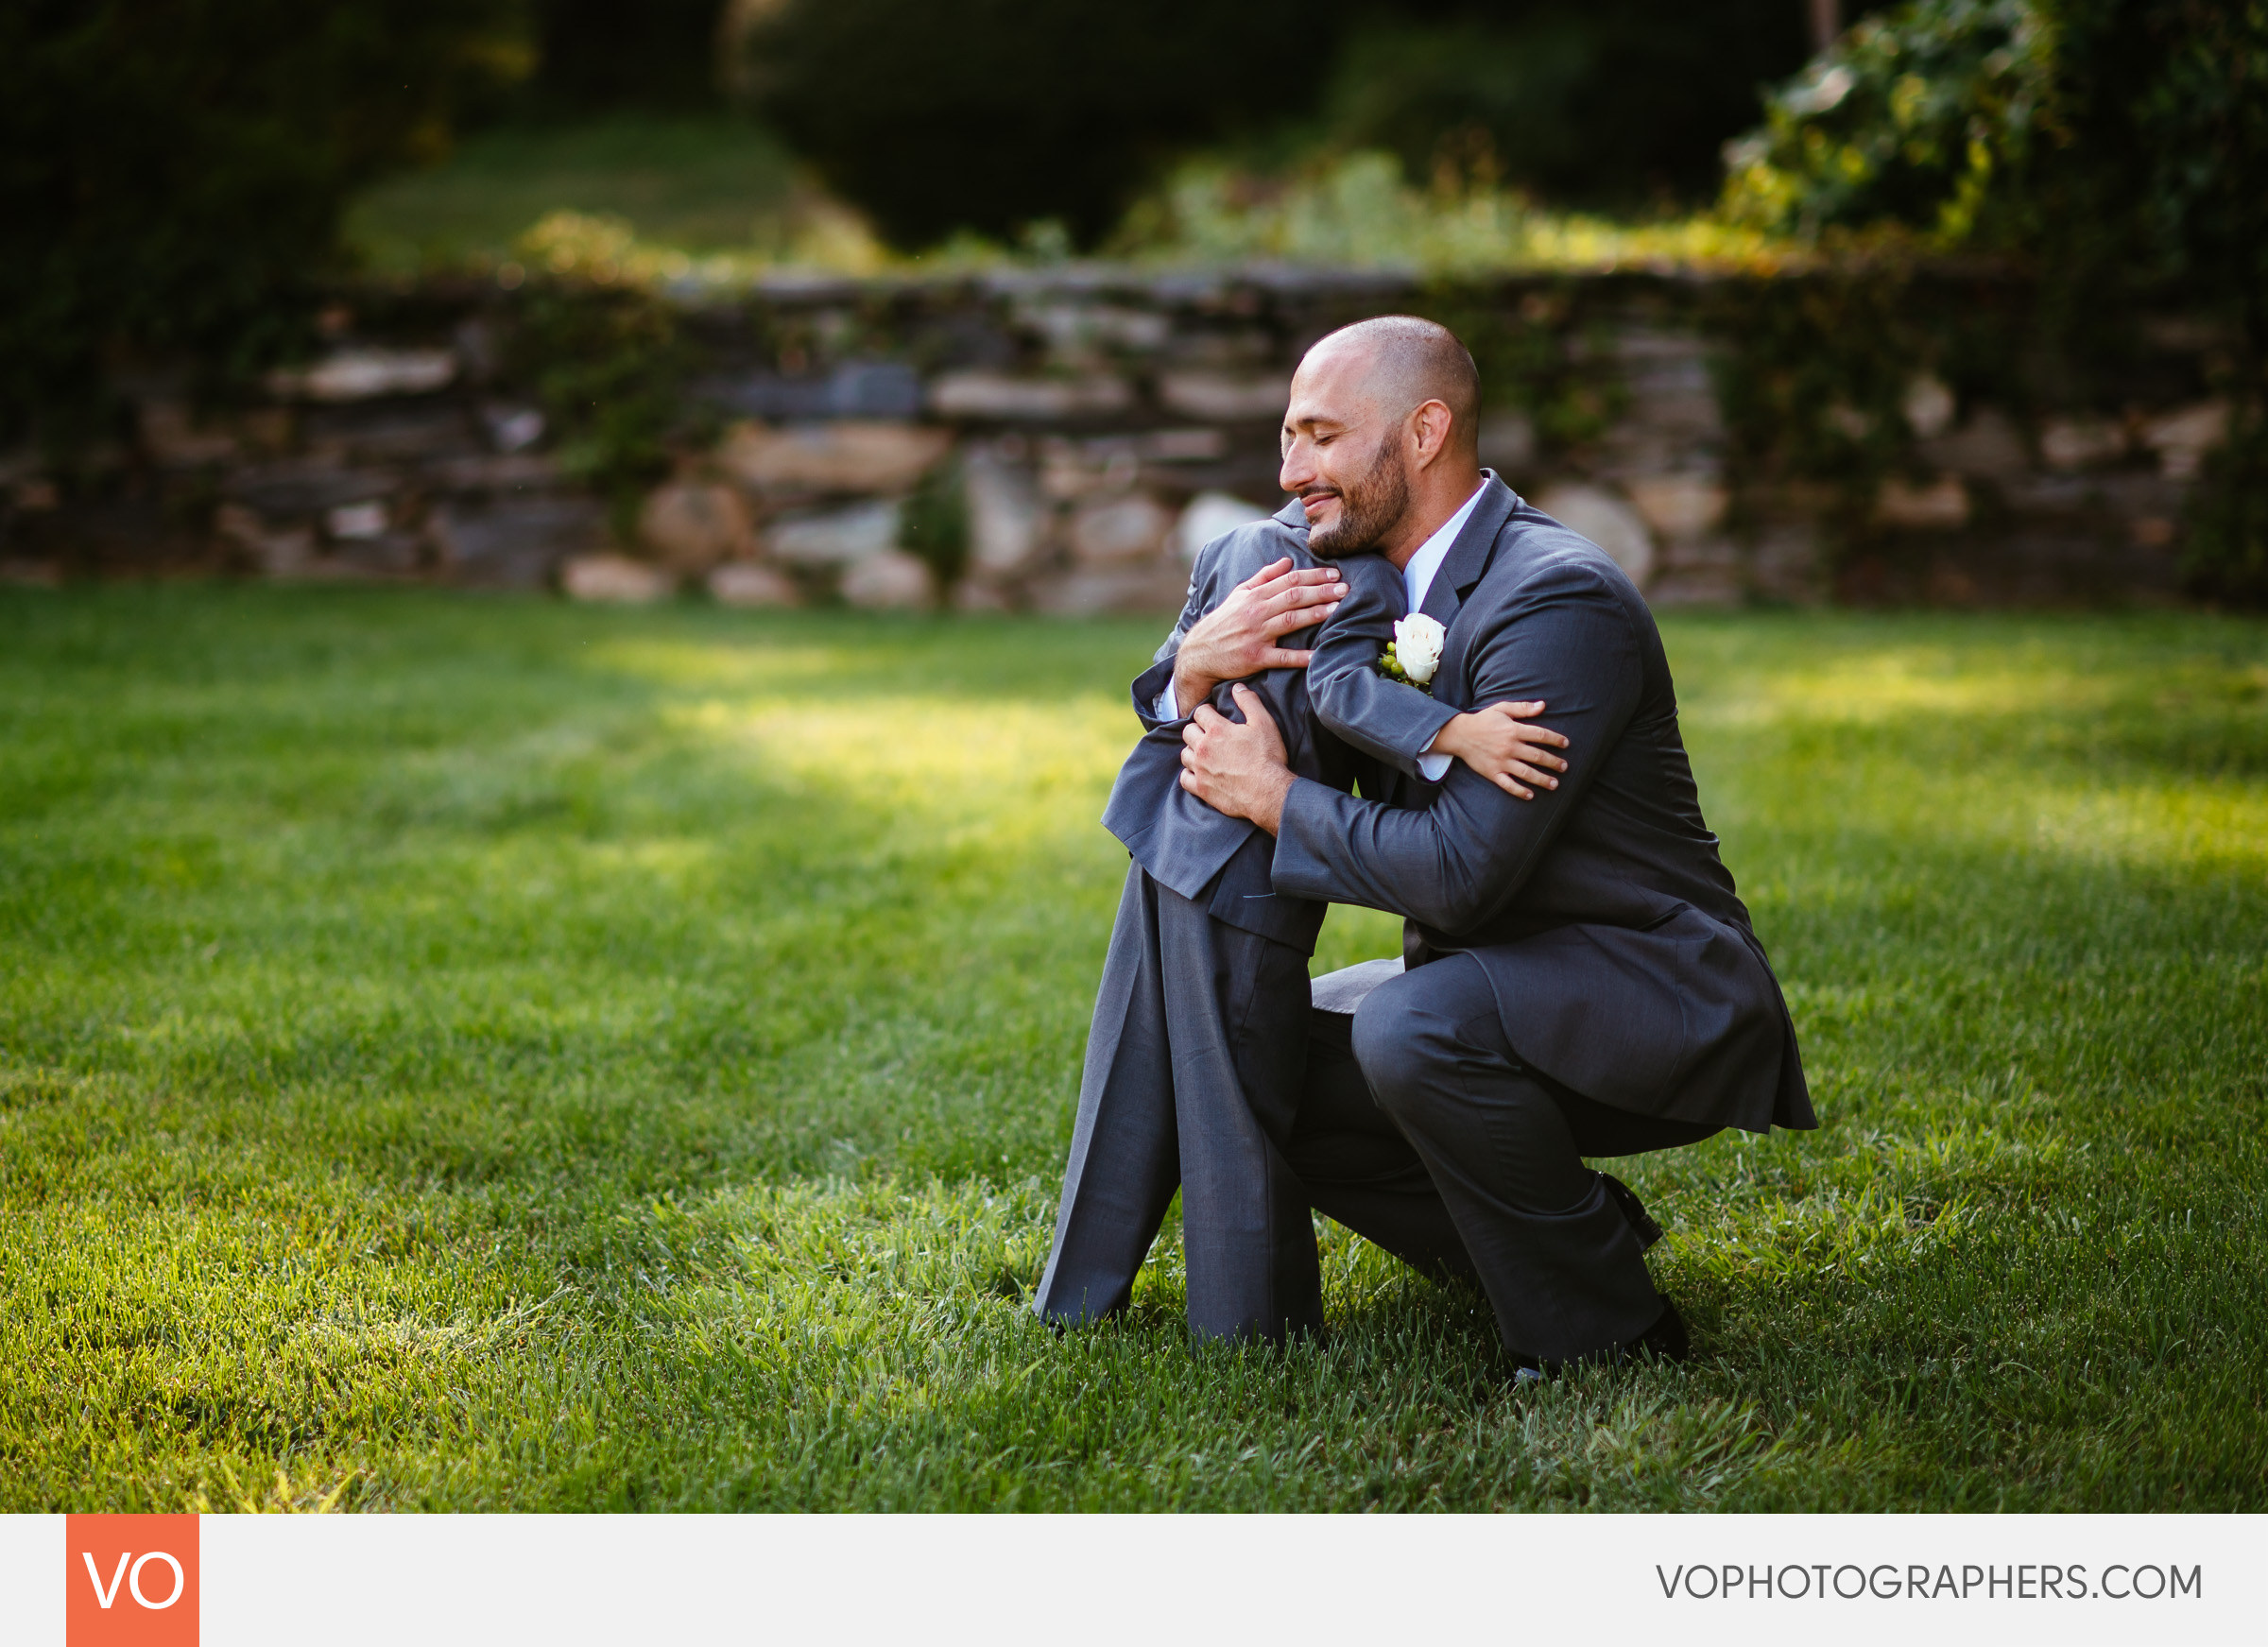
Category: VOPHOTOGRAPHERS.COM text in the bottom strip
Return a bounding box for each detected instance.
[1654,1561,2205,1602]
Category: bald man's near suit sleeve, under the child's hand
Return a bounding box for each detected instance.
[1275,570,1640,933]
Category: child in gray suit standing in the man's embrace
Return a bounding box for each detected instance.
[1034,508,1565,1341]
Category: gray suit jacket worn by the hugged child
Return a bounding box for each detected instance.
[1102,502,1415,952]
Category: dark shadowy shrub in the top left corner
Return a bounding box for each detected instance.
[0,0,528,442]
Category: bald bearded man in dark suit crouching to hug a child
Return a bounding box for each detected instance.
[1175,316,1816,1373]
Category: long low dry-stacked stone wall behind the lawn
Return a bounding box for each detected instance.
[0,267,2225,615]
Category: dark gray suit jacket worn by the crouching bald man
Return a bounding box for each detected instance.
[1275,479,1816,1132]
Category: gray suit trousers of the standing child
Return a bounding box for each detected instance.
[1032,865,1322,1341]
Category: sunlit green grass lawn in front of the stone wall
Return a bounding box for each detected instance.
[0,585,2268,1511]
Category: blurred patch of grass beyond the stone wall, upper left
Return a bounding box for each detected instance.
[347,115,796,272]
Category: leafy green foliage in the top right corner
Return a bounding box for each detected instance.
[1726,0,2268,601]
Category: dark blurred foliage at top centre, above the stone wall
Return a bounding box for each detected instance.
[732,0,1803,245]
